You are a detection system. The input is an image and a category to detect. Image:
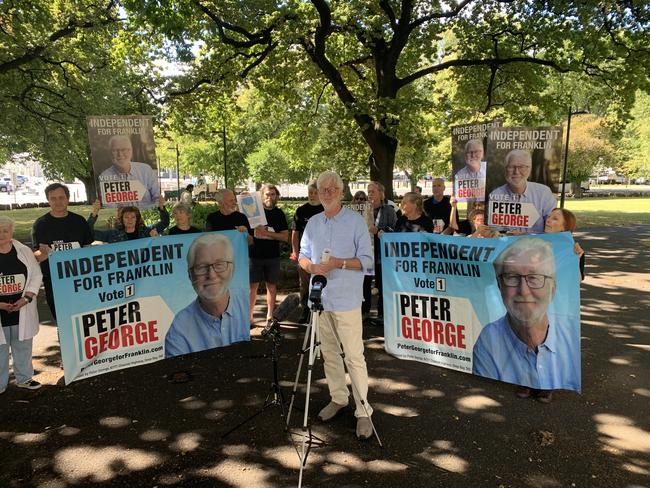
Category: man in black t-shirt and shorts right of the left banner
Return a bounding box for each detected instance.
[250,183,289,326]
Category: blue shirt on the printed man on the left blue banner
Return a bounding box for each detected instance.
[165,290,250,358]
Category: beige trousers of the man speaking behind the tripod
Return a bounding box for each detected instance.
[319,308,372,417]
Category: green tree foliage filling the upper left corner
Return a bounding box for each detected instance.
[0,0,155,198]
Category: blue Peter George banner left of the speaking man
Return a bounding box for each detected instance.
[49,231,250,384]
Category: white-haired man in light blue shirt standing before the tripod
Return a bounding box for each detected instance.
[299,171,373,439]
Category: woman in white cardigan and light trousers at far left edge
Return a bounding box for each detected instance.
[0,216,43,394]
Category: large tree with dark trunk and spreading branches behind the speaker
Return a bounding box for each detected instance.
[126,0,650,198]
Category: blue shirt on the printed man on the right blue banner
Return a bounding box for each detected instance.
[472,314,581,391]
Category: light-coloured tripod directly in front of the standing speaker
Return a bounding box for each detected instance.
[287,299,383,488]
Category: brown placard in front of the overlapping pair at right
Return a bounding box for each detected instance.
[485,127,562,234]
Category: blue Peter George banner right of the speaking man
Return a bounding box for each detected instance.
[381,232,581,391]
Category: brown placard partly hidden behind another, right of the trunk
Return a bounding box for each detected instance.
[451,120,501,202]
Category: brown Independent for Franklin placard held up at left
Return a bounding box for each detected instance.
[87,115,160,208]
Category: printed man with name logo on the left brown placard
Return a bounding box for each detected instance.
[99,135,160,208]
